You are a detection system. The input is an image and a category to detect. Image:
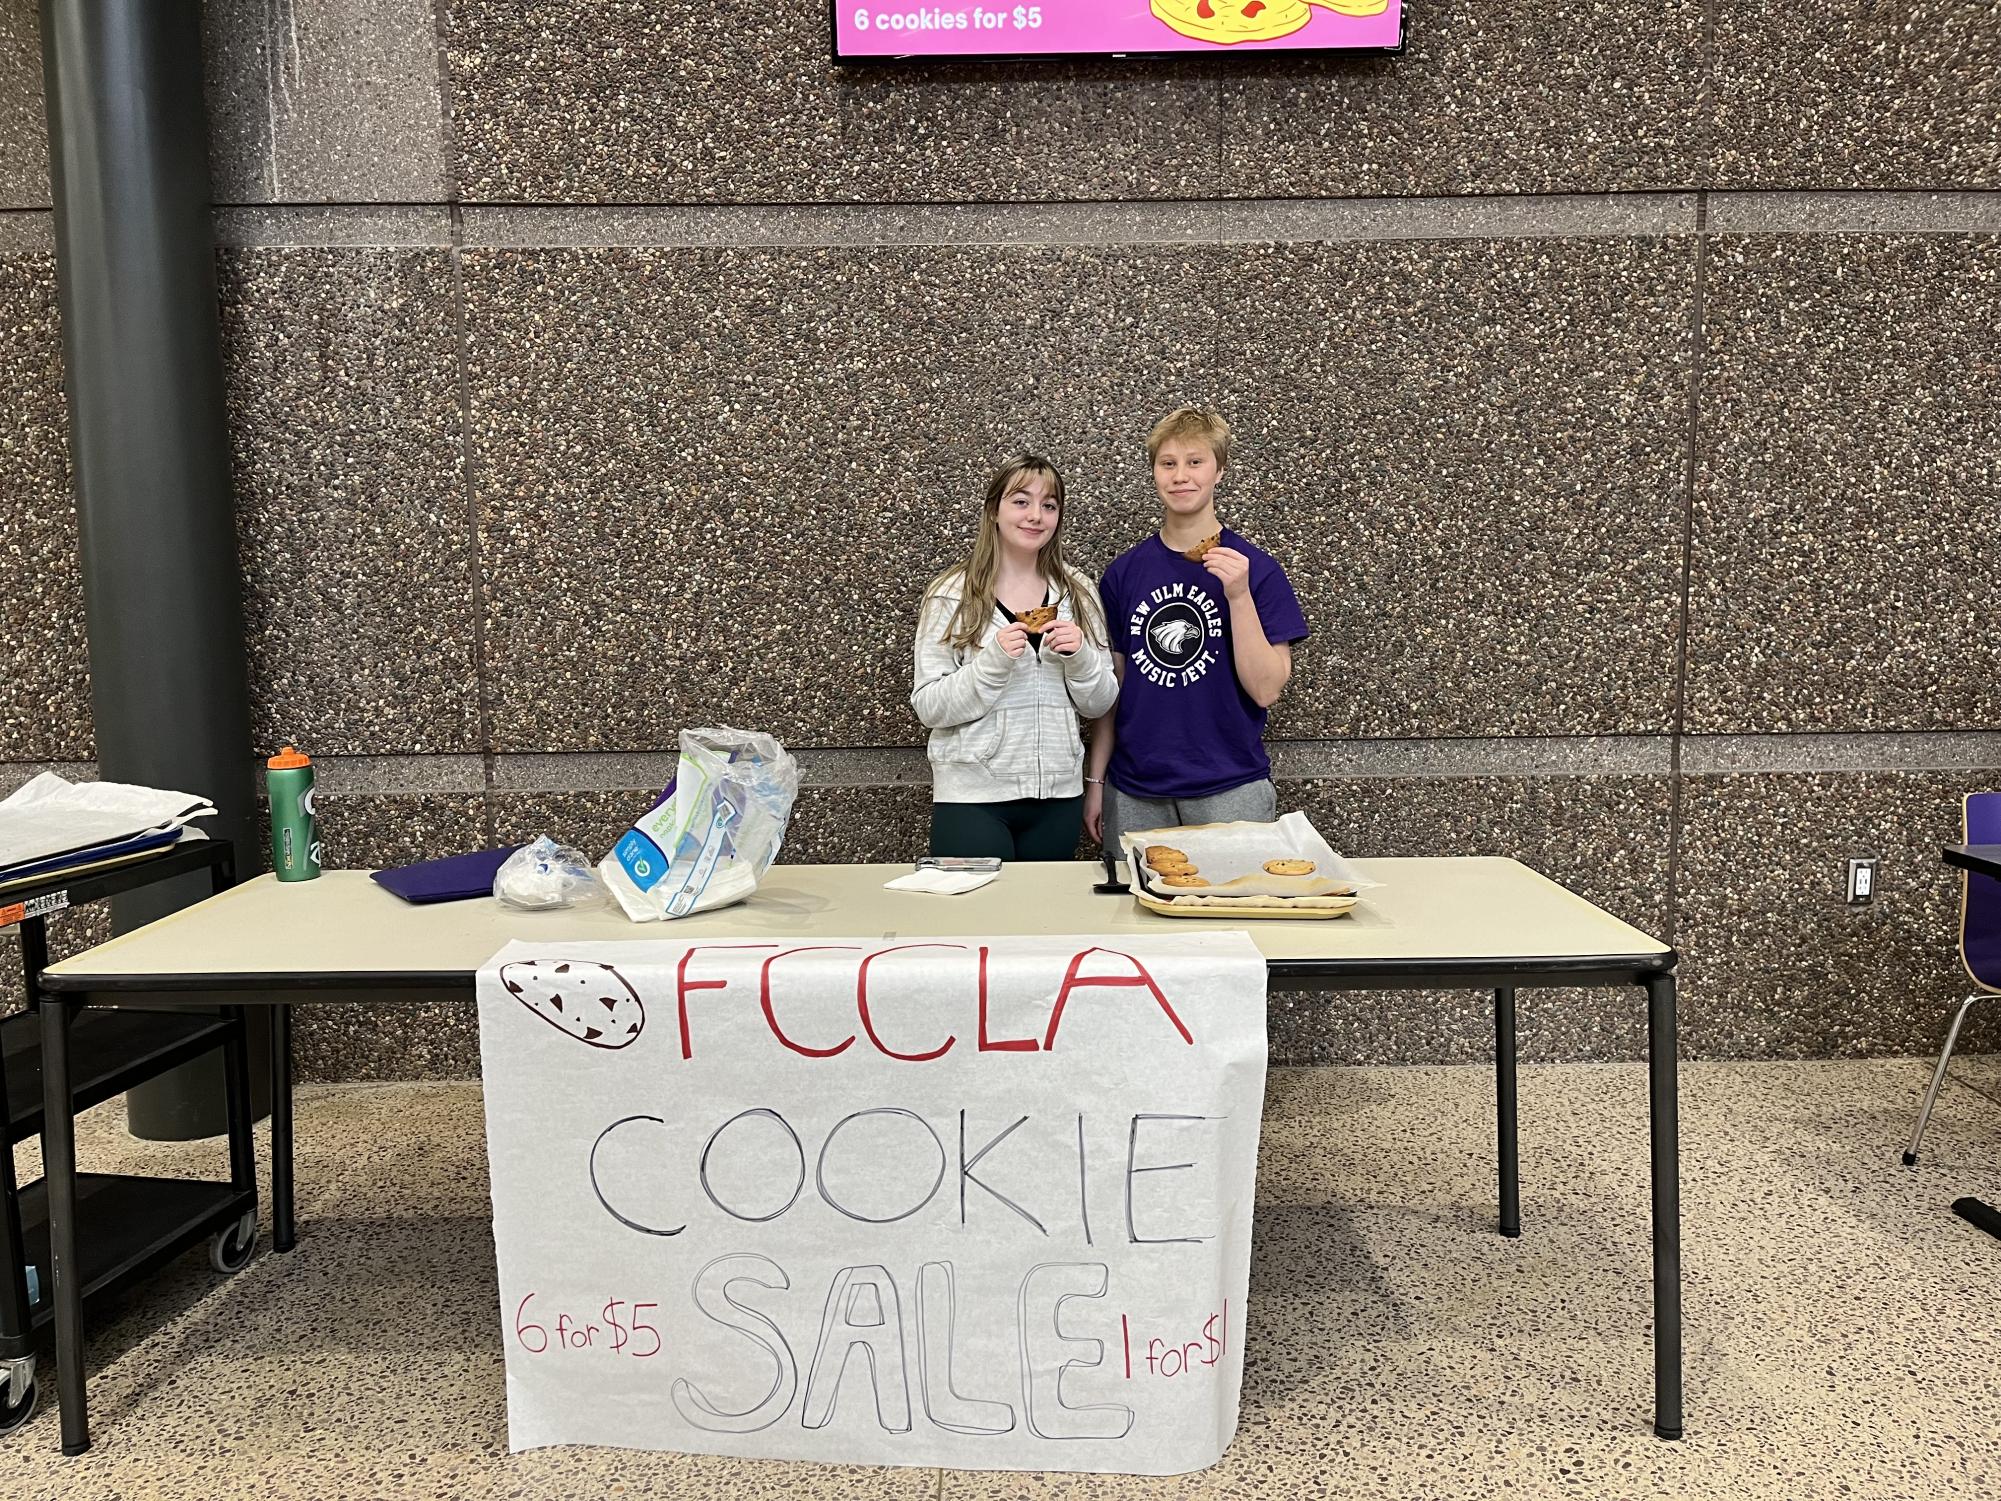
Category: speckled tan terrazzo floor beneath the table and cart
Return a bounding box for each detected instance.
[0,1059,2001,1501]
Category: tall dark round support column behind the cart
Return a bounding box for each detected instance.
[42,0,260,1137]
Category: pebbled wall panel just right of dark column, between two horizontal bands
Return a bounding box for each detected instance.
[220,246,480,755]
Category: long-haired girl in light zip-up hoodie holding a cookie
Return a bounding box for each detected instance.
[910,456,1119,861]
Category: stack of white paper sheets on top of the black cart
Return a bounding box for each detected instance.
[0,771,216,891]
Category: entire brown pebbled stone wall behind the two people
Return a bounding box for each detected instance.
[0,0,2001,1079]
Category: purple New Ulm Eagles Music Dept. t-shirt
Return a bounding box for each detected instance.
[1099,528,1307,799]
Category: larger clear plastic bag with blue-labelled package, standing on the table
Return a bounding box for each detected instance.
[598,728,798,923]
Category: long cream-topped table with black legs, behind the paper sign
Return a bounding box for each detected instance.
[42,857,1683,1453]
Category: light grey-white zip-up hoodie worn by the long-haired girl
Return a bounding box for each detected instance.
[910,568,1119,803]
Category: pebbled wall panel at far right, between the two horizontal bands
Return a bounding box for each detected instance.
[1687,228,2001,732]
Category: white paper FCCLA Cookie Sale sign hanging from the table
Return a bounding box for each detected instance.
[478,931,1265,1475]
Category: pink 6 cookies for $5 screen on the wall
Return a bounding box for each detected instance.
[834,0,1403,58]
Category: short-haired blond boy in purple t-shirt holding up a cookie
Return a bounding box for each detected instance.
[1085,406,1307,851]
